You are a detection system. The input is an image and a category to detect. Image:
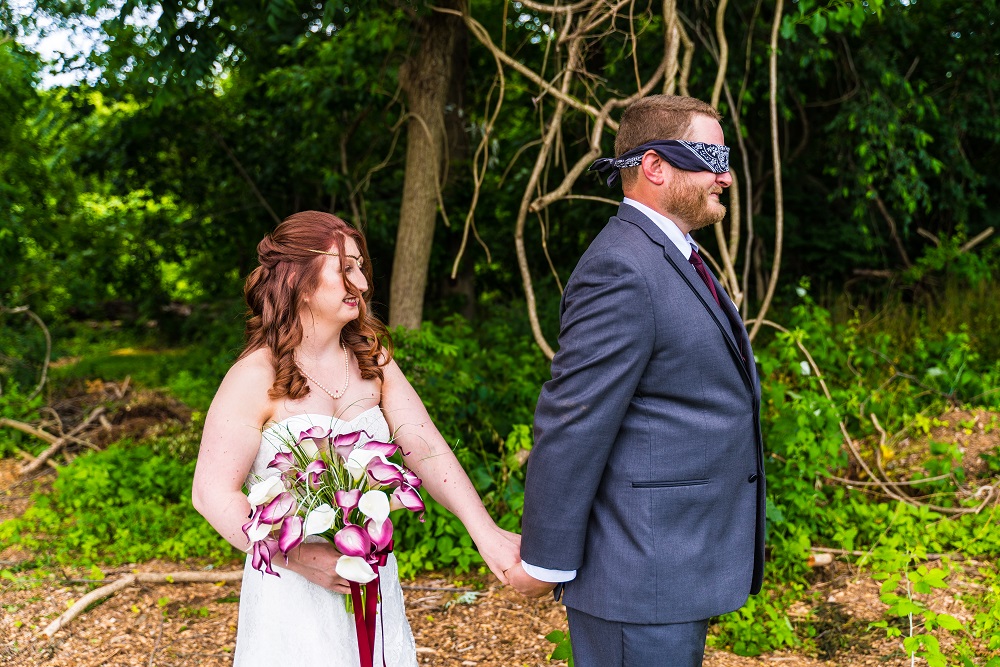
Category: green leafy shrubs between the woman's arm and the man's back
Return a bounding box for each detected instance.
[393,316,548,575]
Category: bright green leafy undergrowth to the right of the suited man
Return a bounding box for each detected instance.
[712,282,1000,664]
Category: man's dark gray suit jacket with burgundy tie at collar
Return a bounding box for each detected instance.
[521,204,764,623]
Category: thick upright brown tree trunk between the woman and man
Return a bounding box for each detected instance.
[389,3,465,329]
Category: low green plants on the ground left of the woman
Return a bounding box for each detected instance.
[0,442,232,565]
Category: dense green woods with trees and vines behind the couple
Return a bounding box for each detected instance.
[0,0,1000,667]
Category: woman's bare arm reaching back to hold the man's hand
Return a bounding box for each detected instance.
[382,361,521,583]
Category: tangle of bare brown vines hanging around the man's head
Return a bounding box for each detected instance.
[456,0,783,358]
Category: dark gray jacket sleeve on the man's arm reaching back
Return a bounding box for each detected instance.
[521,247,655,570]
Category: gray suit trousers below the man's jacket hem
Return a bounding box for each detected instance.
[566,607,708,667]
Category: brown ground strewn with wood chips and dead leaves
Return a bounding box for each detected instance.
[0,412,998,667]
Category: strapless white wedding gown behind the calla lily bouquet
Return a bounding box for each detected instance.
[233,407,417,667]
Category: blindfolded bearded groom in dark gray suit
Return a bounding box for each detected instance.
[507,95,764,667]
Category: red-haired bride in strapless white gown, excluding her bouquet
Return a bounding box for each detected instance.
[192,211,520,667]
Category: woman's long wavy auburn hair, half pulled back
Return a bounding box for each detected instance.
[239,211,392,400]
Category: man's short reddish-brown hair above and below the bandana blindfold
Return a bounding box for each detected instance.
[615,95,722,187]
